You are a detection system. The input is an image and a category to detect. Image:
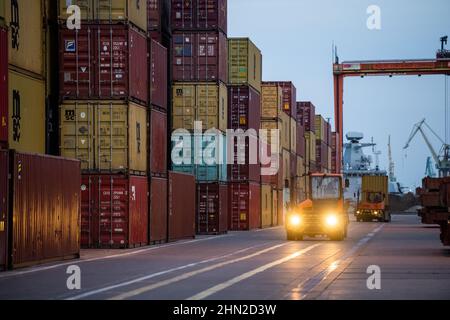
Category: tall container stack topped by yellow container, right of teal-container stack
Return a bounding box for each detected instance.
[228,38,264,230]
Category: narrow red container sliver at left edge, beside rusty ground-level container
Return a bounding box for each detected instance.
[0,150,9,271]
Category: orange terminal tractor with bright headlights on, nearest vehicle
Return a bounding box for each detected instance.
[285,173,349,241]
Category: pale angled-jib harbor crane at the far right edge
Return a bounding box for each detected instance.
[403,119,450,177]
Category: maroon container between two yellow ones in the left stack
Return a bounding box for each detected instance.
[59,24,149,105]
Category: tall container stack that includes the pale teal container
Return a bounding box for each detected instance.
[170,0,228,234]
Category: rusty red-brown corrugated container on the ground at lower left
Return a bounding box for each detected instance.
[5,151,81,268]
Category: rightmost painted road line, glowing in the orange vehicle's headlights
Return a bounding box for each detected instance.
[187,244,322,300]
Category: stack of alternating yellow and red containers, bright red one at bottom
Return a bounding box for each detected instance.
[58,1,149,248]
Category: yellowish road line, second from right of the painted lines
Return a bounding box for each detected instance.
[109,243,289,300]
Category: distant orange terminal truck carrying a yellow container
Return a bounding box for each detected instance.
[355,175,391,222]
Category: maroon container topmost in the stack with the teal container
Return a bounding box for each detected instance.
[171,0,227,33]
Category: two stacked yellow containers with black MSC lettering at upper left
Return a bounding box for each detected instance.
[0,0,47,154]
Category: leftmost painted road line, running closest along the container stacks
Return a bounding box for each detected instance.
[0,234,233,279]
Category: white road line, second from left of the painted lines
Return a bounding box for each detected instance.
[65,243,267,300]
